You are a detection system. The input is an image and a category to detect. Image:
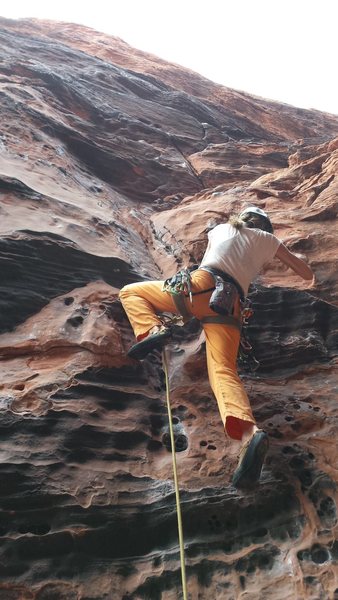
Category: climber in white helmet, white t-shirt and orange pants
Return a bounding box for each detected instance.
[120,206,315,488]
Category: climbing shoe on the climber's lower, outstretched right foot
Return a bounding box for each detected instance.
[232,430,269,488]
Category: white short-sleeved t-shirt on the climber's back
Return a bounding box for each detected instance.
[201,223,281,294]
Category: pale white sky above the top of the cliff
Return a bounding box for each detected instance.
[0,0,338,114]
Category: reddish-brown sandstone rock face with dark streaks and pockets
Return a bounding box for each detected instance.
[0,19,338,600]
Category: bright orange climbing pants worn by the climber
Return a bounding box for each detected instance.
[120,270,255,440]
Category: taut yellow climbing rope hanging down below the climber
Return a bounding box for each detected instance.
[162,348,188,600]
